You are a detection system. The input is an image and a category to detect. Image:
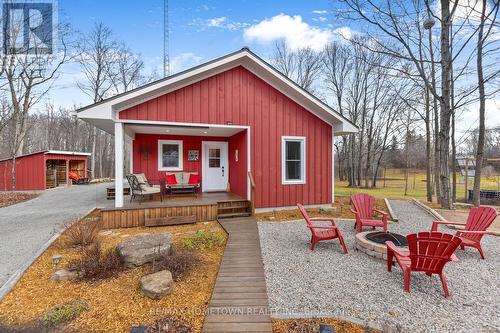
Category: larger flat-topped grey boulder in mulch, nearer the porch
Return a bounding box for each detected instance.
[117,233,172,267]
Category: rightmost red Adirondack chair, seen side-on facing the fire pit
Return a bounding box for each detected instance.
[432,206,498,259]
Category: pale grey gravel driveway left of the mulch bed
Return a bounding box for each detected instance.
[0,183,109,300]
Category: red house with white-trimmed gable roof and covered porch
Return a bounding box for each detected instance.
[78,48,357,211]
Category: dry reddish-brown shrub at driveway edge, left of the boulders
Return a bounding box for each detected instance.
[64,217,101,246]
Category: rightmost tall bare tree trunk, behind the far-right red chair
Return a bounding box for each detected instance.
[472,0,486,207]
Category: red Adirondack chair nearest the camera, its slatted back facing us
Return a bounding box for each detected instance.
[385,232,461,297]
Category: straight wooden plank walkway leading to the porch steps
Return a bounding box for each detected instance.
[203,217,272,333]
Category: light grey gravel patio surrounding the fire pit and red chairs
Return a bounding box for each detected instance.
[258,200,500,332]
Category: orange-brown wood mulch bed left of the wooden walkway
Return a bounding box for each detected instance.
[0,217,225,332]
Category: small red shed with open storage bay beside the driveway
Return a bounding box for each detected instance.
[0,150,90,191]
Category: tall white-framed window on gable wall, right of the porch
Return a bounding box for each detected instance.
[281,136,306,184]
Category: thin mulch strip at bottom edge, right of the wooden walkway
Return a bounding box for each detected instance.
[273,318,378,333]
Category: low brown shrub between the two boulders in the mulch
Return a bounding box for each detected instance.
[153,251,201,281]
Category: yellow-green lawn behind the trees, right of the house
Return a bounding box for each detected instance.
[335,169,500,201]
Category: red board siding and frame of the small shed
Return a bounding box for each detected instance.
[0,152,88,191]
